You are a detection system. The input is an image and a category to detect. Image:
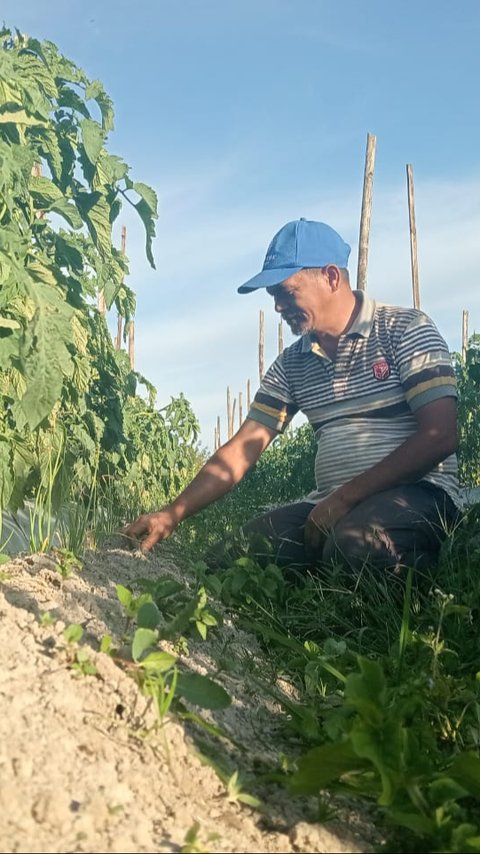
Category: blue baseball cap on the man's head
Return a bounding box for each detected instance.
[238,217,350,294]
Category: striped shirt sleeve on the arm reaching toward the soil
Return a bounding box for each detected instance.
[247,353,298,433]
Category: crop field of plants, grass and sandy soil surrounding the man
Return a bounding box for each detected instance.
[0,30,480,852]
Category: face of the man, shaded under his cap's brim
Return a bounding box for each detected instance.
[267,269,326,335]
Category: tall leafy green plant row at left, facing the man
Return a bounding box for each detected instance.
[0,29,198,524]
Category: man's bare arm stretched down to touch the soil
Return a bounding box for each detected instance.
[123,418,278,552]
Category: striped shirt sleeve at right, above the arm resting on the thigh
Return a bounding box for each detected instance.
[395,312,457,412]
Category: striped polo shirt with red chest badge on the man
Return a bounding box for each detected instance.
[248,291,459,505]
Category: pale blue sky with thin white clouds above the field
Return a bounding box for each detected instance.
[0,0,480,447]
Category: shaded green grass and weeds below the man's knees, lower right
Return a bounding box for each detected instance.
[184,505,480,852]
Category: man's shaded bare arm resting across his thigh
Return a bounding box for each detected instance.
[305,397,458,547]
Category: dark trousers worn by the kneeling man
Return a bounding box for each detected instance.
[213,483,458,570]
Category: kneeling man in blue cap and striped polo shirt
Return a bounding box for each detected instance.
[125,219,458,569]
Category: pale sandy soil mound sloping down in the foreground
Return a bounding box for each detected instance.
[0,549,376,852]
